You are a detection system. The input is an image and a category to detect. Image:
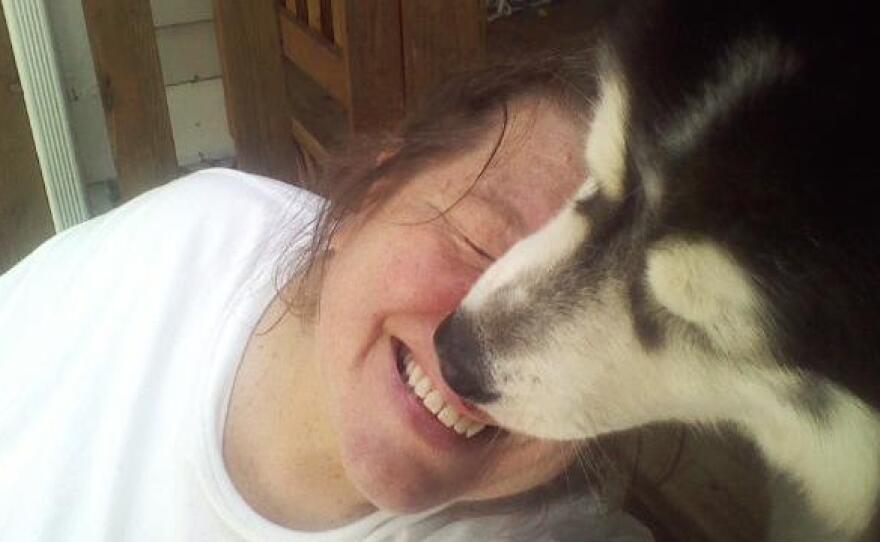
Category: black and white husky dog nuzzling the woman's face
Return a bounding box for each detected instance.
[435,0,880,541]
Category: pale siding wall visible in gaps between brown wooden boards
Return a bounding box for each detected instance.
[47,0,235,194]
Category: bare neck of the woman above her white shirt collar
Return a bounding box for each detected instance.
[223,297,374,531]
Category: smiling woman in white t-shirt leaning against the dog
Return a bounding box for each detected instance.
[0,54,652,540]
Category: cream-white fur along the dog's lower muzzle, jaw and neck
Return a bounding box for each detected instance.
[474,256,880,541]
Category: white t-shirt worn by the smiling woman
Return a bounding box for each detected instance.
[0,169,650,542]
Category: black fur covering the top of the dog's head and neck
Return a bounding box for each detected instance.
[607,0,880,414]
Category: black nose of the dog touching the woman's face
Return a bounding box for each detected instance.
[434,314,498,403]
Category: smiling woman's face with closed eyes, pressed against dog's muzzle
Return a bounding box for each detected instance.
[316,102,585,512]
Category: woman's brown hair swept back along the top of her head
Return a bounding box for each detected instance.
[279,47,595,311]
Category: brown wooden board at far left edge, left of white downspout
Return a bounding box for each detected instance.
[0,10,54,273]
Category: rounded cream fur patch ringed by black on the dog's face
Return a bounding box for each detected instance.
[645,239,765,351]
